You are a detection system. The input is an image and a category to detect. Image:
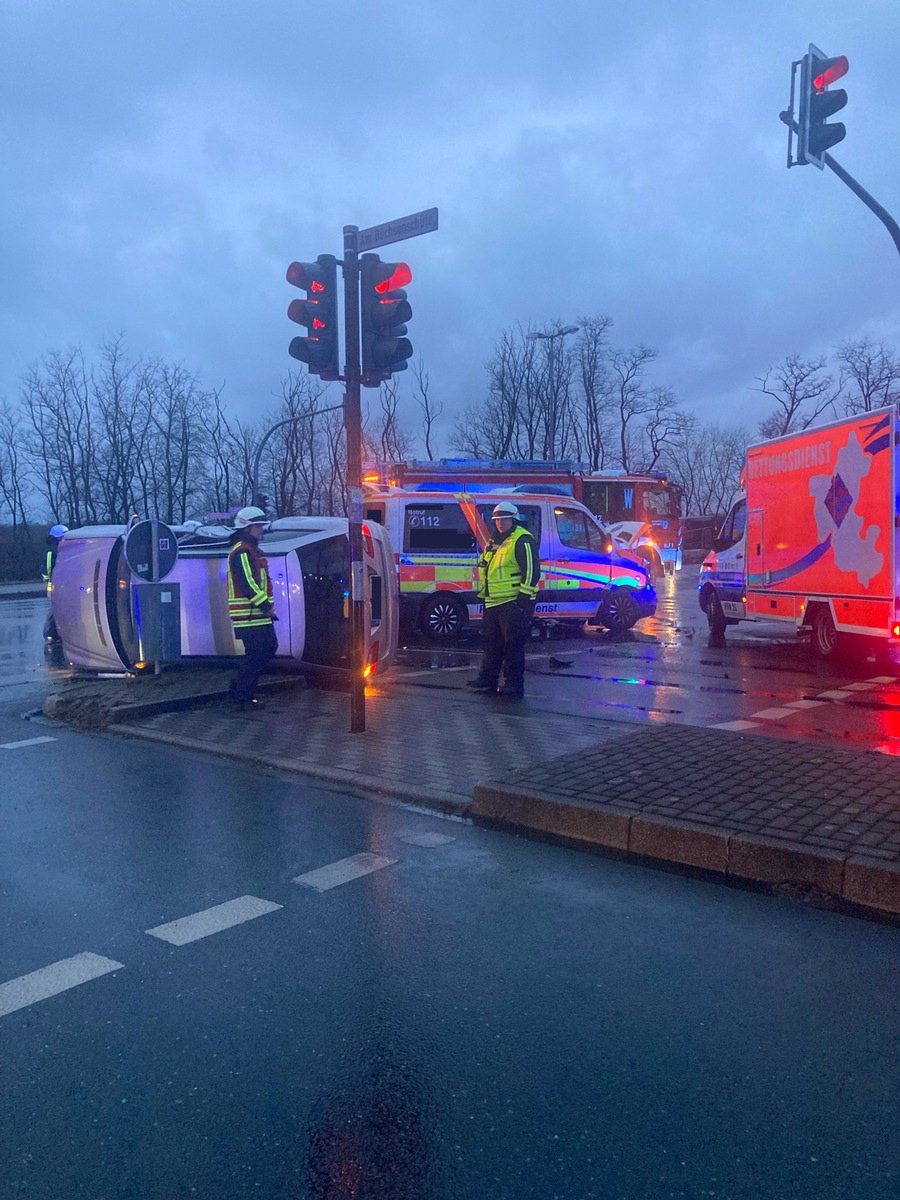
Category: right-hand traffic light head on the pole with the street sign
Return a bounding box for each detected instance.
[359,254,413,388]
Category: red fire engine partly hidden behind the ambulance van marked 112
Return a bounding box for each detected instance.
[364,458,682,575]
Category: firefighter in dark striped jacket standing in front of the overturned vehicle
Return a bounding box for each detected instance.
[228,505,278,709]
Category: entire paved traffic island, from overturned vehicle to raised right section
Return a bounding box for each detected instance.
[48,671,900,914]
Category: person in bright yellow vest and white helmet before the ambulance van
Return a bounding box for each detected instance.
[468,500,541,700]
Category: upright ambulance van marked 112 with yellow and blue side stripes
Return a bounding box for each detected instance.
[362,484,656,641]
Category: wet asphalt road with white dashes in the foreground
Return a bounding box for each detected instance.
[0,706,900,1200]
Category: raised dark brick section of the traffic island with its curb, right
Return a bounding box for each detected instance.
[472,725,900,914]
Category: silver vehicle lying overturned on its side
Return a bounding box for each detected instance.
[52,517,398,673]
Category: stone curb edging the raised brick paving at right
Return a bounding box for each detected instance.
[470,784,900,914]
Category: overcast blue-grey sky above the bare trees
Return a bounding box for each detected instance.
[0,0,900,454]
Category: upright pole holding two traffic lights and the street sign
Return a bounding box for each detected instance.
[343,226,366,733]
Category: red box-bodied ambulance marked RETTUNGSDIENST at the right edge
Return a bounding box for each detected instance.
[700,406,900,661]
